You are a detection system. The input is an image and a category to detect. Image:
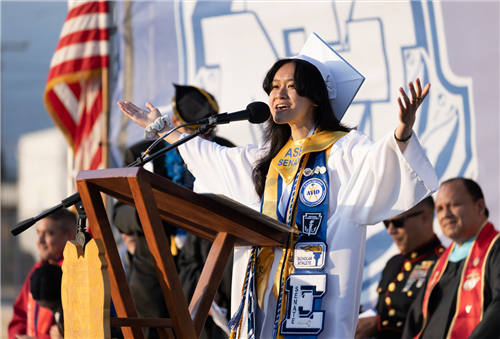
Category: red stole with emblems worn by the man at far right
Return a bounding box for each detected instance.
[415,223,499,339]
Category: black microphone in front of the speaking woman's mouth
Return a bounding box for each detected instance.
[189,101,271,125]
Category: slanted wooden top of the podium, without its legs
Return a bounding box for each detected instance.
[77,168,288,246]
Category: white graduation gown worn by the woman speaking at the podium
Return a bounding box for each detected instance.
[179,131,438,338]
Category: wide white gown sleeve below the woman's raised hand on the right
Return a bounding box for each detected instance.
[329,131,438,225]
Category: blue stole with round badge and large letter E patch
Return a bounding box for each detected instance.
[274,148,330,339]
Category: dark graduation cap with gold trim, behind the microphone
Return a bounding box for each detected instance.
[172,84,219,128]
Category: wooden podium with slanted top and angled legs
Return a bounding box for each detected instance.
[77,167,294,339]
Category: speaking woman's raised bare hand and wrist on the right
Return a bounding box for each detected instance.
[394,78,431,152]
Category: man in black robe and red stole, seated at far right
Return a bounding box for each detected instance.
[403,178,500,339]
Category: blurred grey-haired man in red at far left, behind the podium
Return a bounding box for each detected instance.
[8,209,77,339]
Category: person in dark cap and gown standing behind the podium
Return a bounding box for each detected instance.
[113,84,234,339]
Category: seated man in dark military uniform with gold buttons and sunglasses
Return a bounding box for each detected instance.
[355,196,444,339]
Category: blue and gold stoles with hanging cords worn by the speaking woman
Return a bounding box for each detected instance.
[228,131,346,338]
